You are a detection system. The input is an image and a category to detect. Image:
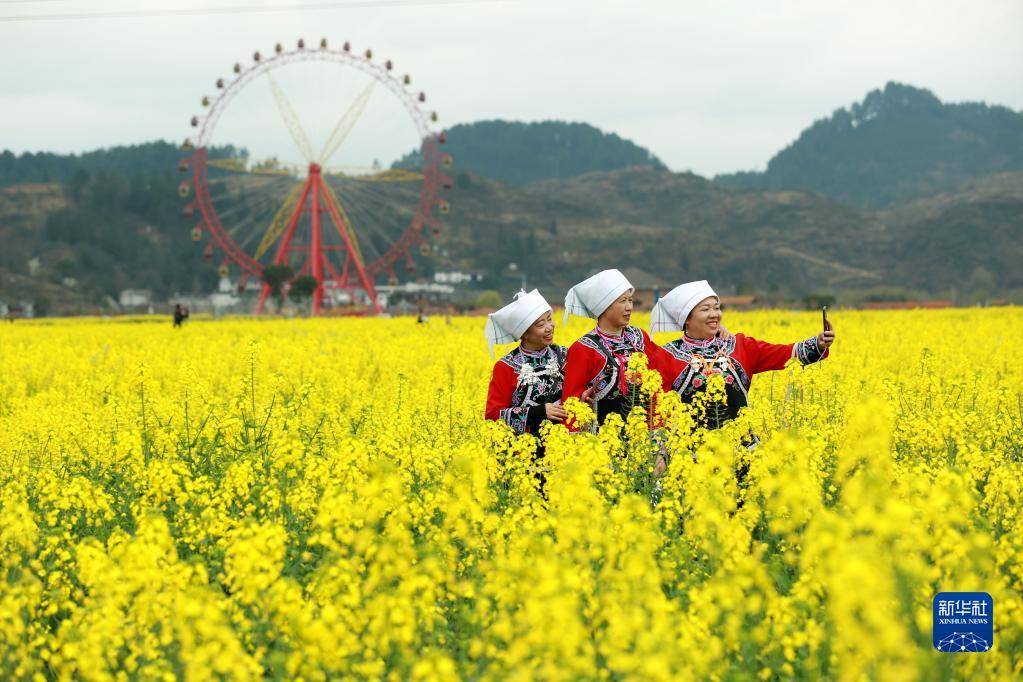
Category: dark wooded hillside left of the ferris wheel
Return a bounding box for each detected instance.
[0,167,216,309]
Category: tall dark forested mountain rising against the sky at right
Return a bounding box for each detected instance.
[715,83,1023,209]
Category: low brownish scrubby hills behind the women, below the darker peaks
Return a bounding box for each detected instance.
[438,168,1023,300]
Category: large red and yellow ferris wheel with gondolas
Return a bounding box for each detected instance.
[179,39,452,314]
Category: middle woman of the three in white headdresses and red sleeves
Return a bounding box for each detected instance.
[562,270,666,423]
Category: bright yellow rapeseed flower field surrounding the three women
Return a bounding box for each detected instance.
[0,309,1023,680]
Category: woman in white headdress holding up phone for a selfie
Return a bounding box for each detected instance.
[650,280,835,428]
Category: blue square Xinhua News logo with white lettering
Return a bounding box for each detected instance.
[932,592,994,653]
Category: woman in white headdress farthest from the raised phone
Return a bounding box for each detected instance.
[486,289,567,434]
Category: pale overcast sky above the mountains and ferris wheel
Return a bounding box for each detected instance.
[0,0,1023,175]
